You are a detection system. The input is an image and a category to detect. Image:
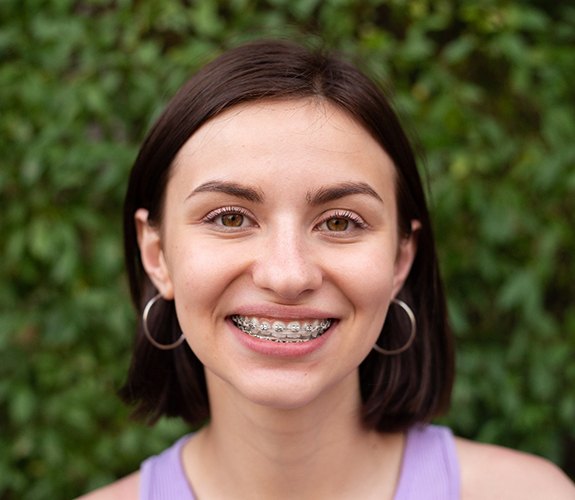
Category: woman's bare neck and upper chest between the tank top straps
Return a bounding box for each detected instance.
[184,375,403,499]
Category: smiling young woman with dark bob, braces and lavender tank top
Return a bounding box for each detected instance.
[81,42,575,500]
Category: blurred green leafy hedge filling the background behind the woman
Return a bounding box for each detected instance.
[0,0,575,500]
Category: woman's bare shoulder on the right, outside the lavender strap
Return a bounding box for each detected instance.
[455,438,575,500]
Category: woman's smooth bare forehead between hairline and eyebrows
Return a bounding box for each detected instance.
[172,99,395,189]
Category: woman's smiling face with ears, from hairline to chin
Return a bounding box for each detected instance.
[140,100,417,408]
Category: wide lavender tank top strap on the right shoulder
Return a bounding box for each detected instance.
[394,425,461,500]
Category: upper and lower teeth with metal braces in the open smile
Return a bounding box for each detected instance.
[231,315,333,343]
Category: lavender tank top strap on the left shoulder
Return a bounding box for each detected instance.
[139,435,195,500]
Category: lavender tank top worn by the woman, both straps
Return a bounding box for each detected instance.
[140,425,460,500]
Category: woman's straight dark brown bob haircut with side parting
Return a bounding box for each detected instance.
[120,41,454,432]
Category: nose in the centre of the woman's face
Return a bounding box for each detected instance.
[252,226,323,301]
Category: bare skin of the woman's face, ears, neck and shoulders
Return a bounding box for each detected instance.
[81,100,575,500]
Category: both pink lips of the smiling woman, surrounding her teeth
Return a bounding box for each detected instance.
[226,306,339,358]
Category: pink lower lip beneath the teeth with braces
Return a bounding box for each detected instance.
[227,318,337,358]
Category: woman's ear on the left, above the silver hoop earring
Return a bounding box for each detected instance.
[134,208,174,300]
